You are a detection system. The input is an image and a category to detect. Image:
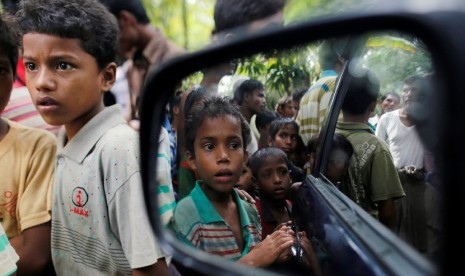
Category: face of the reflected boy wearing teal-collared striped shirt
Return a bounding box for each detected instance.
[187,116,247,193]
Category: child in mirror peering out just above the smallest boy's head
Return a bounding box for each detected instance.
[268,117,305,182]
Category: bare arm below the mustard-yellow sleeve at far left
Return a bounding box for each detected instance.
[10,222,52,275]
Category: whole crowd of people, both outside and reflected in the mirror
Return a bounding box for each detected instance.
[0,0,440,275]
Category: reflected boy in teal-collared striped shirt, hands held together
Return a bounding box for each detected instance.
[171,97,294,267]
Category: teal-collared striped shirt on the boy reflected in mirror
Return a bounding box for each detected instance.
[170,181,261,261]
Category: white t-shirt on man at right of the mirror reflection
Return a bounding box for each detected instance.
[376,109,424,169]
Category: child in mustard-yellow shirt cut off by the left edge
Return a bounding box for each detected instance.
[0,12,56,275]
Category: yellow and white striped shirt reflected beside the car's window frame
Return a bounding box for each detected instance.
[296,70,337,145]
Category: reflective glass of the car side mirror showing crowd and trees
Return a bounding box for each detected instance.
[155,32,440,275]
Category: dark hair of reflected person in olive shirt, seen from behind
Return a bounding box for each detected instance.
[342,68,379,115]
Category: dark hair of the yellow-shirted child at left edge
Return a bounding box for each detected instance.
[0,14,19,77]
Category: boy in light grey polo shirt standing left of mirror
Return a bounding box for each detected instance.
[17,0,171,275]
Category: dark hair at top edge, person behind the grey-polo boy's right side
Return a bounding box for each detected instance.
[99,0,150,25]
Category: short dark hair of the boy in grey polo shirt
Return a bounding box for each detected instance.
[16,0,118,69]
